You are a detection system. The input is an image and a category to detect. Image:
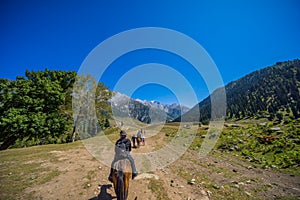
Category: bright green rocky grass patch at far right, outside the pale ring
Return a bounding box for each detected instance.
[217,121,300,175]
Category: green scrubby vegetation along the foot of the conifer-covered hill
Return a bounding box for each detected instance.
[161,119,300,175]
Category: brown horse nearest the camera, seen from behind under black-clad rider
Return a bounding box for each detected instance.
[112,158,132,200]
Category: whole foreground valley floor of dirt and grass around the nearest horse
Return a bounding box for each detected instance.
[0,129,300,200]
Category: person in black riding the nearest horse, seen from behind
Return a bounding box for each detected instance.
[108,130,138,182]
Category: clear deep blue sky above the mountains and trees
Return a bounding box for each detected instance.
[0,0,300,106]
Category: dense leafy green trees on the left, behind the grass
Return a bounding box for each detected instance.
[0,69,111,149]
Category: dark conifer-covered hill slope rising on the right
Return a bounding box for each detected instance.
[174,59,300,122]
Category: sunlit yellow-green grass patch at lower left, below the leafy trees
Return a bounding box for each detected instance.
[0,142,82,200]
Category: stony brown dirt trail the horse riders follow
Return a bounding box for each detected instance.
[26,130,300,200]
